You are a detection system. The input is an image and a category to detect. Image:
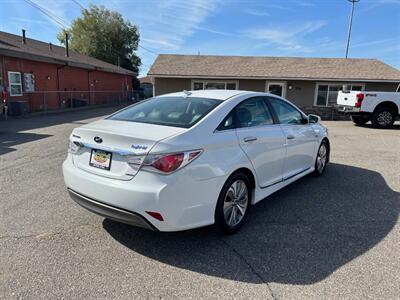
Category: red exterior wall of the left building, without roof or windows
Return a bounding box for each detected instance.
[0,57,132,111]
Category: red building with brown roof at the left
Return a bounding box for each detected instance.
[0,31,136,111]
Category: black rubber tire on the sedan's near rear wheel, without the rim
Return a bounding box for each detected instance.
[215,172,252,234]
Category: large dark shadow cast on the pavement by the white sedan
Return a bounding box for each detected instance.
[103,163,400,284]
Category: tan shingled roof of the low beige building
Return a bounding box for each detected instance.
[148,54,400,81]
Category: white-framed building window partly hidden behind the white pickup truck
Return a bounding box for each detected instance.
[314,83,365,106]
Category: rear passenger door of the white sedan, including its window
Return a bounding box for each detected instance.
[235,97,285,187]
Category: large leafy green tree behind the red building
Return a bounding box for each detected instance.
[57,5,141,72]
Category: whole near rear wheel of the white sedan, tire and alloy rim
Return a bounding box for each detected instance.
[215,172,251,234]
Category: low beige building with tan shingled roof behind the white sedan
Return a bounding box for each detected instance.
[148,54,400,118]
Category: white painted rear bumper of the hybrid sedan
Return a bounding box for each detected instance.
[63,155,226,231]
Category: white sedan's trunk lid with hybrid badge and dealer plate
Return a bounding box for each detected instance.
[71,120,186,180]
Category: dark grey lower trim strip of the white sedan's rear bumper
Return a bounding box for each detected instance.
[68,188,157,230]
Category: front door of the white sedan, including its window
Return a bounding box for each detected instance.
[267,97,317,180]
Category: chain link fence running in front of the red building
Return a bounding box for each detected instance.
[3,91,143,116]
